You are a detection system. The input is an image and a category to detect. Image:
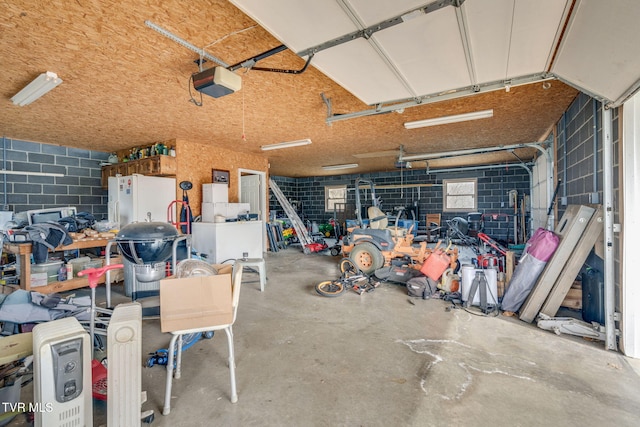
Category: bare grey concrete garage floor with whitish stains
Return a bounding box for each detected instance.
[8,248,640,426]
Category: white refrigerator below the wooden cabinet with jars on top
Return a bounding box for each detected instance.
[108,175,179,227]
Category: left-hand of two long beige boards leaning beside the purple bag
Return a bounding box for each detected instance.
[519,205,595,323]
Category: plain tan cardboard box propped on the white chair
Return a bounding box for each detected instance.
[160,274,233,332]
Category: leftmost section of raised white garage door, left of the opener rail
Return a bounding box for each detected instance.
[231,0,359,52]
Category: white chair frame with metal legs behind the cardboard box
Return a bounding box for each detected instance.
[162,266,243,415]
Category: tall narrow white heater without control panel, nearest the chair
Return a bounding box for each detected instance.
[107,302,152,427]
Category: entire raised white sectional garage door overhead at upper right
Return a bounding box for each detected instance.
[230,0,640,105]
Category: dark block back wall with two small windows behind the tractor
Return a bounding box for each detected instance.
[270,167,530,241]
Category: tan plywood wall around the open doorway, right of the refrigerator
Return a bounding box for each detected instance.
[175,139,269,216]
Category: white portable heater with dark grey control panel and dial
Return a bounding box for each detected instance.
[33,317,93,427]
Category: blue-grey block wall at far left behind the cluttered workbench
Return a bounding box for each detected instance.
[0,138,109,220]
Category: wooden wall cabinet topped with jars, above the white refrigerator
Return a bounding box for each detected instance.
[102,143,176,189]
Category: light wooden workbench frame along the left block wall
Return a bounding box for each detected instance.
[4,239,111,294]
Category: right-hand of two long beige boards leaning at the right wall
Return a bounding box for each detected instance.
[540,206,604,317]
